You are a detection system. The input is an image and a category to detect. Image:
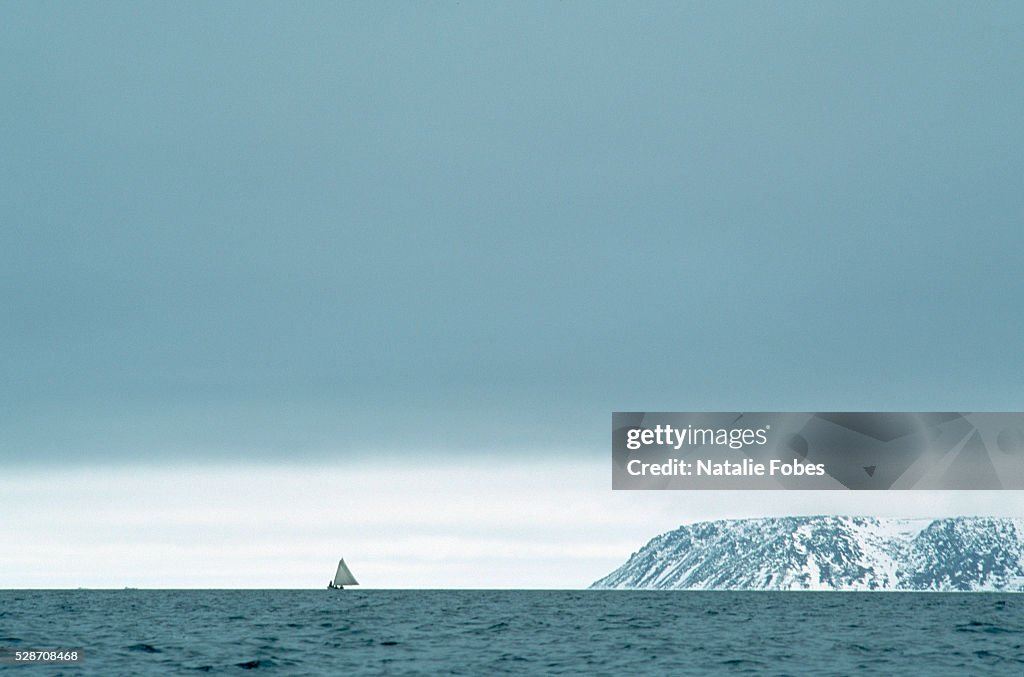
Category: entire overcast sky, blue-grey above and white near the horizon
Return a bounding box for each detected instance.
[0,2,1024,587]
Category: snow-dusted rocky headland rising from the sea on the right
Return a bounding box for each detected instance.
[591,516,1024,592]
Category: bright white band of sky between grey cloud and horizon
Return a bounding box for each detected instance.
[0,454,1024,588]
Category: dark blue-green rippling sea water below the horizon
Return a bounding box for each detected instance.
[0,589,1024,676]
